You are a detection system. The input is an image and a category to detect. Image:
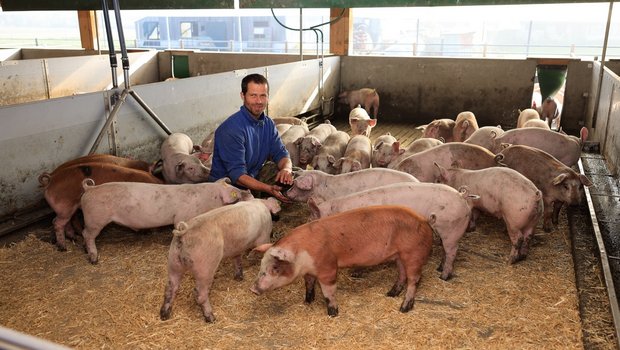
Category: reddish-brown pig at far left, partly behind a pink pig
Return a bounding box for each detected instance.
[43,162,162,251]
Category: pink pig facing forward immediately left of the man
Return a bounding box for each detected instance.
[160,132,210,184]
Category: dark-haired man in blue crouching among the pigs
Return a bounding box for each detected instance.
[209,74,293,202]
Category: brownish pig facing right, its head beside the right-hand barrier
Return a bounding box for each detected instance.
[496,145,592,232]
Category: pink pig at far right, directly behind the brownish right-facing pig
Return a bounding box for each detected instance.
[492,127,588,167]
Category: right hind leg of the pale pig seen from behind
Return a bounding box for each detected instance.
[190,249,224,323]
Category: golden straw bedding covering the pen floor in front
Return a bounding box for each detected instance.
[0,200,600,349]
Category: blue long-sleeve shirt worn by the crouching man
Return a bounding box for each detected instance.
[209,106,289,184]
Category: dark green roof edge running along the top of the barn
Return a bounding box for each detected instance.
[0,0,608,11]
